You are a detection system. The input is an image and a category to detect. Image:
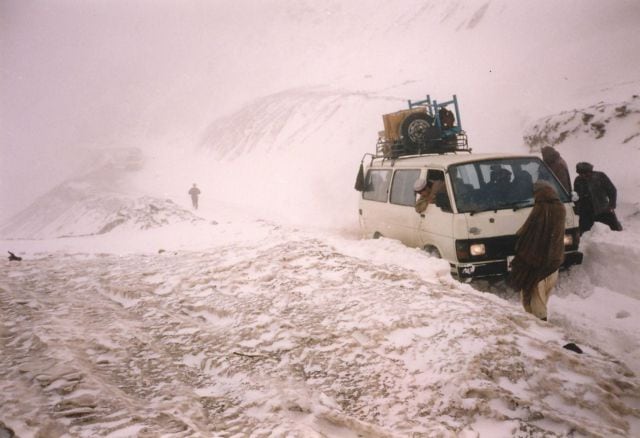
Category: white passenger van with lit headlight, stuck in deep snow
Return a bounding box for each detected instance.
[359,152,582,280]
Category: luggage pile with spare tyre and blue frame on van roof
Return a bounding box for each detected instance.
[376,94,471,158]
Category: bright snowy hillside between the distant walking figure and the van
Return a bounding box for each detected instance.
[136,87,412,229]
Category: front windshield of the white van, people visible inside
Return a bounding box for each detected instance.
[449,157,571,213]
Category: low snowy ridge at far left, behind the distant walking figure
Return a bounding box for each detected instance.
[0,149,202,239]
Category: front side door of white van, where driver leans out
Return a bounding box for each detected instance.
[416,169,455,260]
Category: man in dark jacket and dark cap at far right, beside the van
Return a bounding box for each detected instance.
[573,162,622,234]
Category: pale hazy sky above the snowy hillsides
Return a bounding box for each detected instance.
[0,0,640,220]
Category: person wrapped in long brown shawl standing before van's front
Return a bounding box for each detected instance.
[509,181,567,321]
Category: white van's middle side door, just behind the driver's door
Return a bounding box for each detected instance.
[389,169,421,247]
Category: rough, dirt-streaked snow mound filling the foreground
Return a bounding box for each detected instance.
[0,217,640,437]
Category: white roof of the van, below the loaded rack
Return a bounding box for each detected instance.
[370,153,539,168]
